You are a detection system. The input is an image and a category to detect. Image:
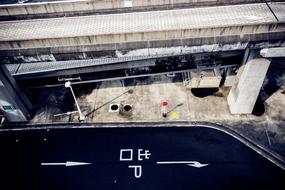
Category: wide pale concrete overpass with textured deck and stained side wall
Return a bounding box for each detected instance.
[0,3,285,62]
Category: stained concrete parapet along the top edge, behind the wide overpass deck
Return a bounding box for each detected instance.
[0,0,276,20]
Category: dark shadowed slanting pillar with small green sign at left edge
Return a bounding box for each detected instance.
[0,65,32,123]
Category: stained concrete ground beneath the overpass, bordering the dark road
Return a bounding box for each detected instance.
[28,75,272,123]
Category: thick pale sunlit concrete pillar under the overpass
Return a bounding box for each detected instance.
[227,58,270,114]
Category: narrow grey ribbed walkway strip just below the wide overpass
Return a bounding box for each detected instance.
[6,49,244,78]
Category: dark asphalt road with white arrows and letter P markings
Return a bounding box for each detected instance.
[0,127,285,190]
